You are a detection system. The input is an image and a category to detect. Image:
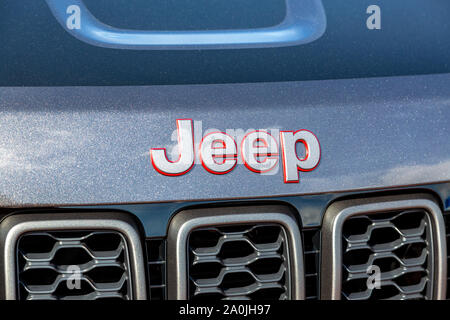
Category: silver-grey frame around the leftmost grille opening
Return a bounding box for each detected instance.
[0,212,147,300]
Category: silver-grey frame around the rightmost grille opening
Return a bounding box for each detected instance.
[321,194,447,300]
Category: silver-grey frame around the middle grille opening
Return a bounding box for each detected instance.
[168,205,305,300]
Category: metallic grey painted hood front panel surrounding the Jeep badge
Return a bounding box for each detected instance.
[0,74,450,206]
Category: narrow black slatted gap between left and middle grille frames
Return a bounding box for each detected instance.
[147,239,167,300]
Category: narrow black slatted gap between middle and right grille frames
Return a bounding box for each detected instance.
[302,229,320,300]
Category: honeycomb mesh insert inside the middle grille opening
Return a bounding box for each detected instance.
[189,224,290,300]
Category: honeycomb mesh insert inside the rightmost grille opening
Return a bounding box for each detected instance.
[342,210,432,300]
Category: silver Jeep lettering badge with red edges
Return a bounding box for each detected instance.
[150,119,320,183]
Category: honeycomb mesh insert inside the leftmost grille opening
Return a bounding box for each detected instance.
[17,231,132,300]
